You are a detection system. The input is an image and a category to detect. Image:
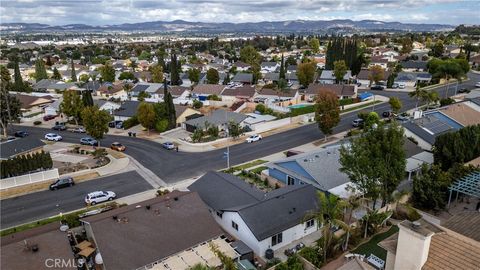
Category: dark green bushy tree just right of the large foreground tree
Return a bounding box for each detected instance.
[412,164,452,210]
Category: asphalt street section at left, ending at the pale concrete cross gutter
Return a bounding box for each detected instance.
[0,171,152,228]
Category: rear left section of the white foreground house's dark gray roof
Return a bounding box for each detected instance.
[188,171,264,211]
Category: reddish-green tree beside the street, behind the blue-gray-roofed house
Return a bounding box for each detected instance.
[315,91,340,140]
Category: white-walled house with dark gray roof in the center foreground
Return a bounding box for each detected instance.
[188,171,318,257]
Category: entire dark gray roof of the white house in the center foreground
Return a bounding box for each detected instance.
[188,172,317,241]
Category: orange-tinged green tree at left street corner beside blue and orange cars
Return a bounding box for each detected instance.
[81,105,112,146]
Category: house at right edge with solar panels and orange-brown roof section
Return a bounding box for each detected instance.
[403,99,480,151]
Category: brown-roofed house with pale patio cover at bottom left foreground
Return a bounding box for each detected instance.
[81,191,242,270]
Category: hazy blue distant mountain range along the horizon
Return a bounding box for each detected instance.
[0,20,455,33]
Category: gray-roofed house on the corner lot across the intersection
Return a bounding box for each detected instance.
[182,110,248,132]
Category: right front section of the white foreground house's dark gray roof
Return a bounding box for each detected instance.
[238,185,318,241]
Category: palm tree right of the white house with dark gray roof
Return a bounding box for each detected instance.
[306,191,348,262]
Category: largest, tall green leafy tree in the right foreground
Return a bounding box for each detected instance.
[340,122,406,207]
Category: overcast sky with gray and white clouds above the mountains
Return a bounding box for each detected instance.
[0,0,480,25]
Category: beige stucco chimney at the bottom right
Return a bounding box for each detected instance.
[393,220,434,270]
